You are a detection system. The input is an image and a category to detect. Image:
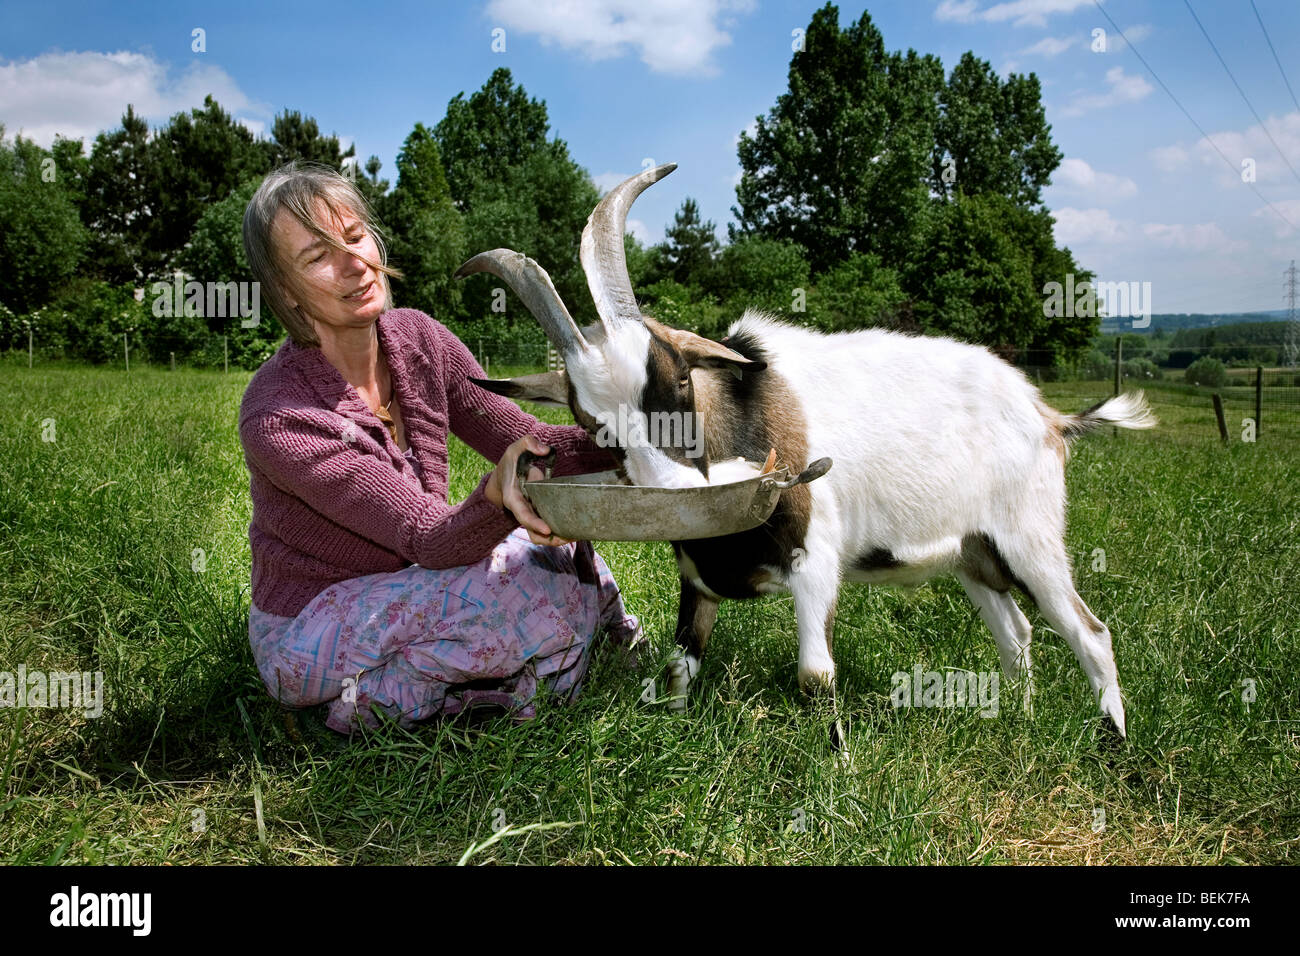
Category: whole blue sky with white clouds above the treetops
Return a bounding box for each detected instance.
[0,0,1300,312]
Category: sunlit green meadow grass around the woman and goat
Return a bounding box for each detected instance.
[0,356,1300,864]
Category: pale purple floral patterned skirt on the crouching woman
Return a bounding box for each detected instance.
[248,528,641,732]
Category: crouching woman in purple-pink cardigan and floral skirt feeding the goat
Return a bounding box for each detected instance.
[239,164,641,731]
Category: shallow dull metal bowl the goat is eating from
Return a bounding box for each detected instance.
[523,462,794,541]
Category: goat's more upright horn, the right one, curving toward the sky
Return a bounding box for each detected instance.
[581,163,677,332]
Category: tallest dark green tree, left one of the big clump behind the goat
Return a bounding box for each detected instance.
[732,4,944,273]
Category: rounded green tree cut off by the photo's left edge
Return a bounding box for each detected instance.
[0,126,87,312]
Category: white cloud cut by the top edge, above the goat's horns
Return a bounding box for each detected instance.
[488,0,754,75]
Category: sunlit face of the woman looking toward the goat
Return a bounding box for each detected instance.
[270,203,387,337]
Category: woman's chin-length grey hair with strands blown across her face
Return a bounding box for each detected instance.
[243,160,402,346]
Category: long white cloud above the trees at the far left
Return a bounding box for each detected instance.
[0,51,269,150]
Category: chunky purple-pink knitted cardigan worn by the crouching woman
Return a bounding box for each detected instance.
[239,308,614,617]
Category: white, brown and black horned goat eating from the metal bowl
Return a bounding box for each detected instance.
[456,164,1156,736]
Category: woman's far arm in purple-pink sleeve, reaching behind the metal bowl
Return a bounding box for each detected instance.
[430,321,616,475]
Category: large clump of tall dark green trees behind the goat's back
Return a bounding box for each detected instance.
[732,4,1097,365]
